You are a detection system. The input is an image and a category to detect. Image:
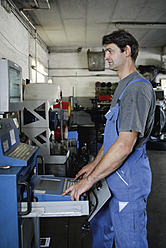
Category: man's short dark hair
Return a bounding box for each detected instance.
[102,29,139,62]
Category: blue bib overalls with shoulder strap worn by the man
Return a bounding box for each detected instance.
[90,78,152,248]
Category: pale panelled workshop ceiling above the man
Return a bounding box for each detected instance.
[13,0,166,50]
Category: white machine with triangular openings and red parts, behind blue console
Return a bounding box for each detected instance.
[21,83,70,164]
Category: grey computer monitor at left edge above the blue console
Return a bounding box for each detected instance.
[0,59,22,113]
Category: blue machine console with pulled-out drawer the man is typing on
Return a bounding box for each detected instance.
[0,119,111,248]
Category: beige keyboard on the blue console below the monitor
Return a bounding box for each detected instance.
[7,143,37,161]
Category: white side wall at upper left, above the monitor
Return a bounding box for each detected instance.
[0,5,48,82]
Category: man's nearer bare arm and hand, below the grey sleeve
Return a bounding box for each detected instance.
[63,131,138,201]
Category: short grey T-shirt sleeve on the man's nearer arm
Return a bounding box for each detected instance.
[119,83,151,138]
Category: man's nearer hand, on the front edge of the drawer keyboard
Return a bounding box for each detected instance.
[62,177,93,201]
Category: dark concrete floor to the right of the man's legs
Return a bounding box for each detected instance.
[147,151,166,248]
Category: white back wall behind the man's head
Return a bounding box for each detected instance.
[49,47,162,97]
